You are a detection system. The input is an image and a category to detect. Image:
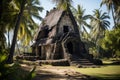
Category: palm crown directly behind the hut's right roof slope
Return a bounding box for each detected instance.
[71,5,90,37]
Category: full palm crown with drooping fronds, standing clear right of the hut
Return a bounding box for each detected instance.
[90,9,110,43]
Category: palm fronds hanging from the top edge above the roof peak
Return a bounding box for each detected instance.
[52,0,72,10]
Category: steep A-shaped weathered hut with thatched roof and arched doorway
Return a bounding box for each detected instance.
[32,8,88,60]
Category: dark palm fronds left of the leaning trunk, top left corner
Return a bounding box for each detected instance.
[0,0,19,48]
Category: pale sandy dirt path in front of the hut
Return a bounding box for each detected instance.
[22,65,93,80]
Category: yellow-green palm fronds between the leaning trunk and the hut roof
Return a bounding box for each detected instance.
[18,0,43,46]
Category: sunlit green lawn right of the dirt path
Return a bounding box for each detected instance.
[76,61,120,80]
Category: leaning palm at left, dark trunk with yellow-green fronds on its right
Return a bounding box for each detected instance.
[8,0,43,63]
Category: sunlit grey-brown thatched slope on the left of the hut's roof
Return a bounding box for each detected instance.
[34,9,64,40]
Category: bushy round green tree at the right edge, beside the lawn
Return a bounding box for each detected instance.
[101,29,120,57]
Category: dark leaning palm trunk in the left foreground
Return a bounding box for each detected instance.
[7,0,26,63]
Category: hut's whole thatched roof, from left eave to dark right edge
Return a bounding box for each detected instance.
[33,8,79,45]
